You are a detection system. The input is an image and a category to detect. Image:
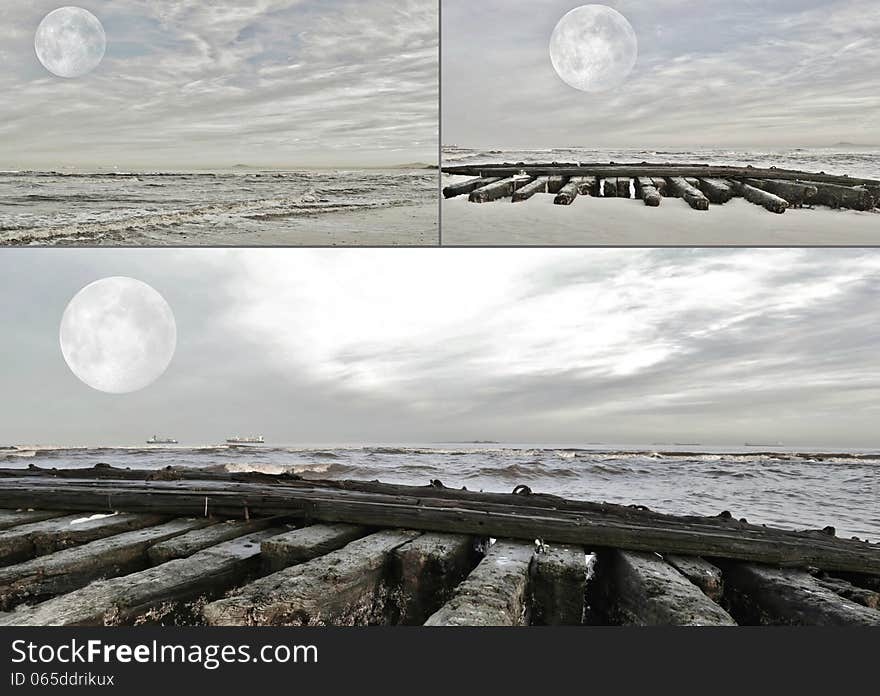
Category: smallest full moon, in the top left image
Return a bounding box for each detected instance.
[34,7,107,77]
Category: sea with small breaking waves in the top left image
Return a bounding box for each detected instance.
[0,169,437,246]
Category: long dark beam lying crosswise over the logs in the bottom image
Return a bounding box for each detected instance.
[0,476,880,575]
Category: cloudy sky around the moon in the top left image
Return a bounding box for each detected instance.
[0,0,439,169]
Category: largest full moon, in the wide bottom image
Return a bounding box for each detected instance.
[60,277,177,394]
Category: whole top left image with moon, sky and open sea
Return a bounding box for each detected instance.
[0,0,439,246]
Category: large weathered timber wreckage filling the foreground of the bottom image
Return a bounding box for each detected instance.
[0,468,880,626]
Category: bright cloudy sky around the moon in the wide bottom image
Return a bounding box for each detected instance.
[0,249,880,447]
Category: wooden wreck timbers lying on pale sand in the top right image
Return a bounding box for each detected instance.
[442,162,880,213]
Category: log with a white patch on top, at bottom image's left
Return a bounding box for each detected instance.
[0,513,168,566]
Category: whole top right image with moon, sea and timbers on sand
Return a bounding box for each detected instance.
[441,0,880,246]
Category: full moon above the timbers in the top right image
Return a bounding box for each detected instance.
[550,5,639,92]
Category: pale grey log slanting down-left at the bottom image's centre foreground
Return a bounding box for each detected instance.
[425,539,535,626]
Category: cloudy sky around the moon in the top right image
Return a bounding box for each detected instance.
[442,0,880,148]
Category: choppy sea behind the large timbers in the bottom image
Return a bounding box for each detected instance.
[0,443,880,542]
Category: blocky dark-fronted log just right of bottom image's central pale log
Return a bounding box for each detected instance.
[531,545,587,626]
